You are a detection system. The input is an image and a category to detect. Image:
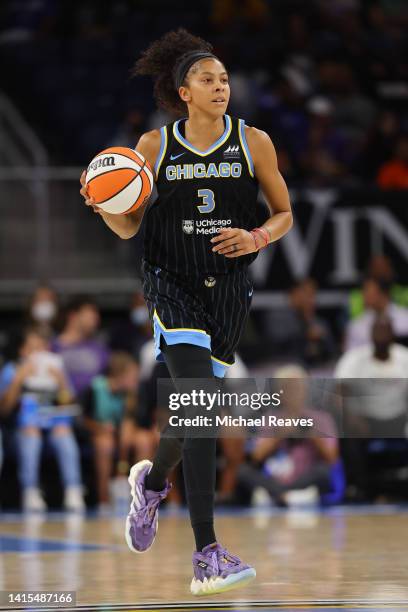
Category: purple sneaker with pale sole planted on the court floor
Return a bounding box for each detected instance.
[190,542,256,595]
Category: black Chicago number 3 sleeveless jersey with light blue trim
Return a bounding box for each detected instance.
[144,115,258,276]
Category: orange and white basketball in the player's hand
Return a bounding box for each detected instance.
[85,147,153,215]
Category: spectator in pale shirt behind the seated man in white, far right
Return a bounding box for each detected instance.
[345,277,408,350]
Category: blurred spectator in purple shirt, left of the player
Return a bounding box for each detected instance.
[52,297,109,397]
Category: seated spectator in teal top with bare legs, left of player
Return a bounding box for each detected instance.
[82,352,155,505]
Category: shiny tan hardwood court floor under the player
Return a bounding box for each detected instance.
[0,507,408,612]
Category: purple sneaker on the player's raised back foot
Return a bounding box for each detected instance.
[125,459,171,553]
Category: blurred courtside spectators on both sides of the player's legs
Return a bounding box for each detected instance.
[0,256,408,511]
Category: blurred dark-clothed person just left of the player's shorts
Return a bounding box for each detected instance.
[109,291,152,361]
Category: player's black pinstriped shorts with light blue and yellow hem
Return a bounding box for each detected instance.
[142,260,253,376]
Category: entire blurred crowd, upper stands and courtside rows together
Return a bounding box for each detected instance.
[0,0,408,512]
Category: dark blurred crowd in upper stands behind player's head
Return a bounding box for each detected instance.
[0,0,408,189]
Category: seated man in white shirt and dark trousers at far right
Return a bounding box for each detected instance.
[334,315,408,500]
